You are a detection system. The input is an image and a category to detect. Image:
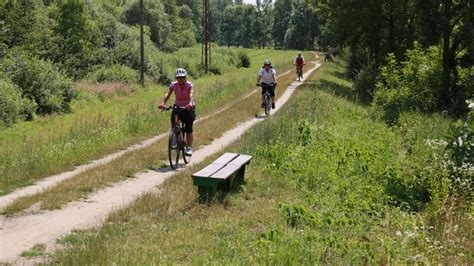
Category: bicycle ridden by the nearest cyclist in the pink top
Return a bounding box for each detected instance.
[163,105,191,170]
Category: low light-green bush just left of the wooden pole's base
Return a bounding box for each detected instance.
[86,65,138,83]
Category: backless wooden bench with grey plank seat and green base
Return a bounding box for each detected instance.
[192,153,252,200]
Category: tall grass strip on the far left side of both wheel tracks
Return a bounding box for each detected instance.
[0,50,293,195]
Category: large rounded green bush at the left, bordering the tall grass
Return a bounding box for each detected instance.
[0,51,76,114]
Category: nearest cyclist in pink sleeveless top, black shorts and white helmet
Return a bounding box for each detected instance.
[160,68,196,156]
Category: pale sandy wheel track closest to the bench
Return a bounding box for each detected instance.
[0,56,321,264]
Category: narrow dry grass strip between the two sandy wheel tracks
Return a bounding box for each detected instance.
[2,51,314,215]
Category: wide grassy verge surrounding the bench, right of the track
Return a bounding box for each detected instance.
[46,60,474,264]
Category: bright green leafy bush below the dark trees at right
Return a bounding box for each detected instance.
[372,44,443,122]
